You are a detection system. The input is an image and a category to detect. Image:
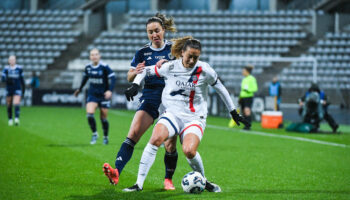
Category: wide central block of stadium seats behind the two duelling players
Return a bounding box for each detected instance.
[80,10,312,87]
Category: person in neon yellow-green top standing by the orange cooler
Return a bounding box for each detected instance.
[239,65,258,130]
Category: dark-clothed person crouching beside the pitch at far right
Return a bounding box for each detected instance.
[298,83,339,133]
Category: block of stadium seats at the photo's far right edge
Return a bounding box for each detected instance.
[280,32,350,89]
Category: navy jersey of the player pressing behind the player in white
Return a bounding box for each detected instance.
[131,40,173,99]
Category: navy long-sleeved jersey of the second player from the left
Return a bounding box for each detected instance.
[81,62,115,97]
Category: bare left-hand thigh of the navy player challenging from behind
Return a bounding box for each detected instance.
[128,110,154,143]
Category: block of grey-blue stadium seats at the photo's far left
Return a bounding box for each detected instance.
[0,10,83,76]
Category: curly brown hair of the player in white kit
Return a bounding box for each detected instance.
[171,36,202,58]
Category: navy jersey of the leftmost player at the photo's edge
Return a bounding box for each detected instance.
[1,65,24,90]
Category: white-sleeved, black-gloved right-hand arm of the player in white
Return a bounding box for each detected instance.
[206,67,250,126]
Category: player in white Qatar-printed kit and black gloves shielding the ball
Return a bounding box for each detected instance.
[124,37,250,192]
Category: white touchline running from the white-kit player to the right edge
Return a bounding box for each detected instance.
[207,124,350,148]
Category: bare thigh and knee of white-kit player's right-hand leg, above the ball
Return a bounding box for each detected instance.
[182,132,201,159]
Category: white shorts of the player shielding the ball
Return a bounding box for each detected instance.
[157,112,206,143]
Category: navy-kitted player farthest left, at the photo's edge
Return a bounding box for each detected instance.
[1,55,25,126]
